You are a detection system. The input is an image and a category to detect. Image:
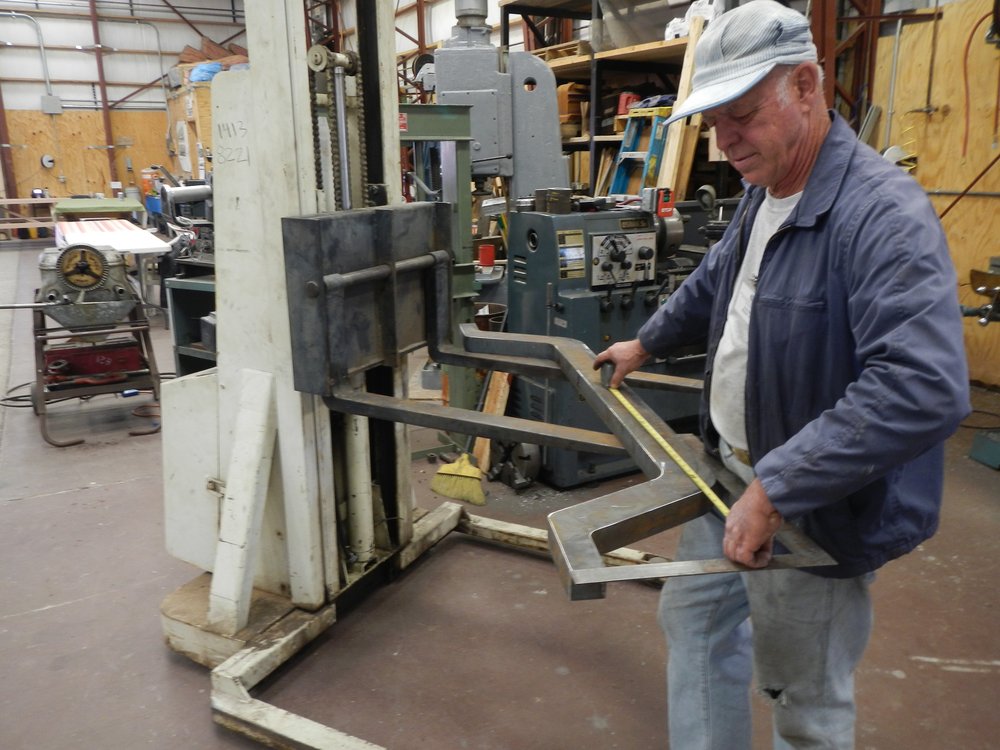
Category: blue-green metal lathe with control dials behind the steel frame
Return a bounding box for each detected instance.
[507,191,706,489]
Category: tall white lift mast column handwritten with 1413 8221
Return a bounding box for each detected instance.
[212,0,333,608]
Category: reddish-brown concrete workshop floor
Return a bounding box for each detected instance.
[0,244,1000,750]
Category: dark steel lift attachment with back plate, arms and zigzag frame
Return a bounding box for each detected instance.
[285,203,833,599]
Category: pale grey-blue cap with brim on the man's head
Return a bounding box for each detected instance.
[667,0,817,125]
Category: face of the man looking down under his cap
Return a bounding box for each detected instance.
[704,69,804,195]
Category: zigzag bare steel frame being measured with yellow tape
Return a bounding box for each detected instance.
[454,328,835,600]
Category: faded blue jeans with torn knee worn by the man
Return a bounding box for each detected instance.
[659,500,874,750]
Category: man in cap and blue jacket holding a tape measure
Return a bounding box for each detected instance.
[594,0,969,750]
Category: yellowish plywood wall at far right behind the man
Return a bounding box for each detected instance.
[872,0,1000,386]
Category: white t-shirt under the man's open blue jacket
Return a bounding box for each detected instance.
[709,190,802,450]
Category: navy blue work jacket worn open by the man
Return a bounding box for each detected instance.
[638,113,970,578]
